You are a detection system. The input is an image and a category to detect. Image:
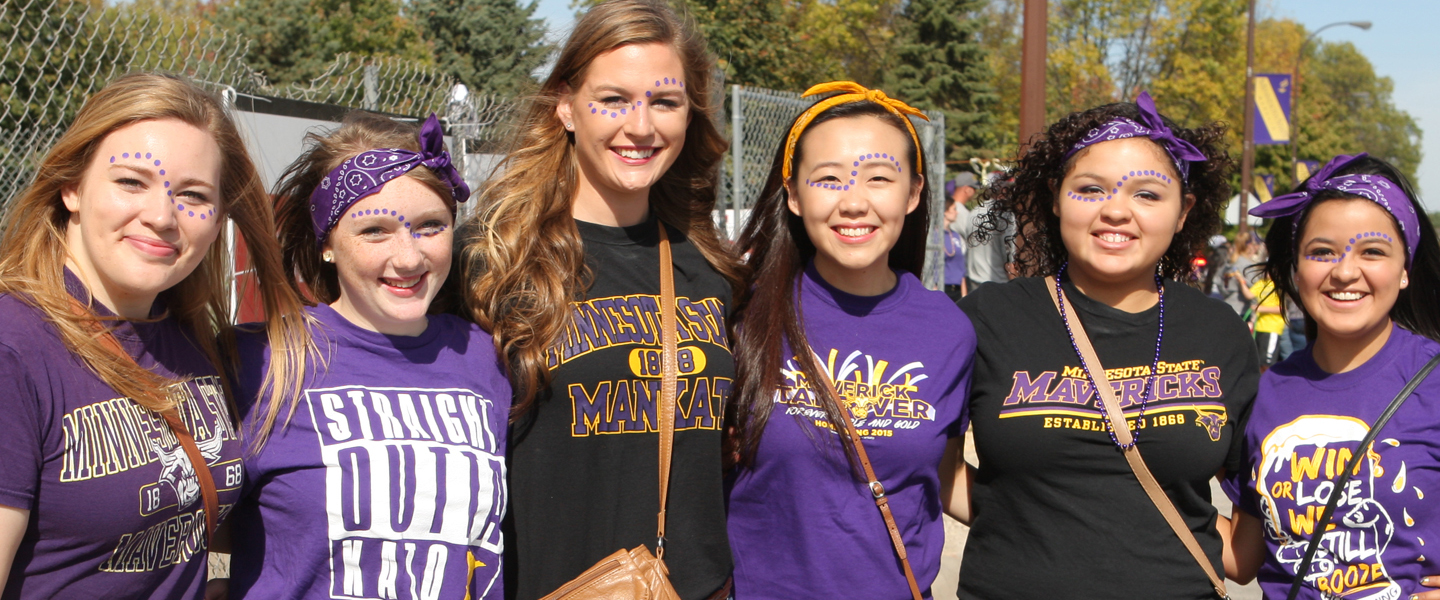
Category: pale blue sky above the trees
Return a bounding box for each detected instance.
[536,0,1440,205]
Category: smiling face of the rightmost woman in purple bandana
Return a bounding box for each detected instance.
[1295,199,1410,341]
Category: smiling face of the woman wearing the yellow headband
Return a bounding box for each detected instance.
[786,115,923,295]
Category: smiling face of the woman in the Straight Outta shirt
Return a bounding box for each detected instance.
[325,177,454,335]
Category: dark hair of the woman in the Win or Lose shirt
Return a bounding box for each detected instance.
[1264,157,1440,341]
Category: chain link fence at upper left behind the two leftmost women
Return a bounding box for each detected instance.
[0,0,466,209]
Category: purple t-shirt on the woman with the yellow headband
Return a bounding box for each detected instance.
[729,266,975,600]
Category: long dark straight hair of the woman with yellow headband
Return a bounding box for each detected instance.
[726,101,930,466]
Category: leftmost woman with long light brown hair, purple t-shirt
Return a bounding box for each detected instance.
[0,75,307,599]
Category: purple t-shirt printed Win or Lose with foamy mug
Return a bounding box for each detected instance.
[1227,327,1440,600]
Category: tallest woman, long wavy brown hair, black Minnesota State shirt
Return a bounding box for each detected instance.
[461,0,743,599]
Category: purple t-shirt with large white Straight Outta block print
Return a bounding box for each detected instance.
[230,305,510,600]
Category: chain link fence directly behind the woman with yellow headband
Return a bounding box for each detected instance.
[716,85,945,289]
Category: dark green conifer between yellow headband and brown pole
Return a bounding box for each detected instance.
[886,0,996,163]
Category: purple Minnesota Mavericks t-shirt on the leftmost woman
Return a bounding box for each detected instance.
[0,272,242,599]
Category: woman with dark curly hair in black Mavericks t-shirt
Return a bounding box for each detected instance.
[959,94,1259,599]
